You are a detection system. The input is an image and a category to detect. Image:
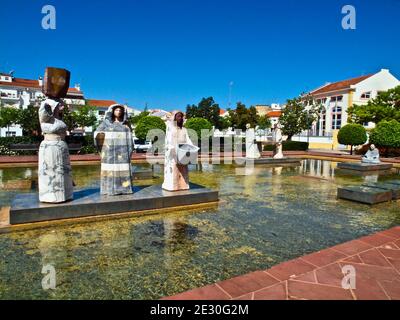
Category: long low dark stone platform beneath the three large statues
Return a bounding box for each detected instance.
[10,184,218,225]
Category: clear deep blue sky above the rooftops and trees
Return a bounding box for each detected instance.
[0,0,400,110]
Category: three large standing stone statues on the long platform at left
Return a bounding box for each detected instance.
[38,68,199,203]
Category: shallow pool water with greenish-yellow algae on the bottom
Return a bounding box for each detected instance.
[0,160,400,299]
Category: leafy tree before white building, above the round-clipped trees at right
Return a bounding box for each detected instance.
[347,86,400,124]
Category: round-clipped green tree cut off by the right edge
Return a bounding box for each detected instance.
[370,120,400,153]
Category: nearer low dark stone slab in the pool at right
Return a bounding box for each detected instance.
[337,186,393,204]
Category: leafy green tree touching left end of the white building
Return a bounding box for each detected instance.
[279,97,318,140]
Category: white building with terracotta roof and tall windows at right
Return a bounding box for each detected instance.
[309,69,400,136]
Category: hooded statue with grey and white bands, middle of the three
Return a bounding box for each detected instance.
[94,104,133,196]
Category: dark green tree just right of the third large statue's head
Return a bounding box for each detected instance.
[186,97,220,129]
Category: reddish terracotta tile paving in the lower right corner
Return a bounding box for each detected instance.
[164,226,400,300]
